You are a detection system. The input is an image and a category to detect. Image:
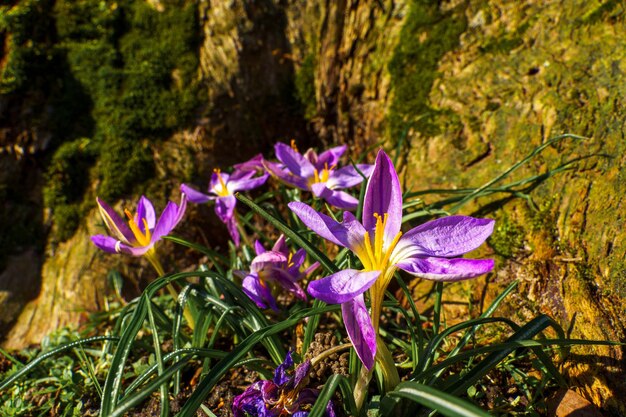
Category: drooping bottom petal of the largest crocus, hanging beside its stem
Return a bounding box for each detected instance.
[341,294,376,369]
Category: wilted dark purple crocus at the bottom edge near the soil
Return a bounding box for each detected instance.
[232,352,335,417]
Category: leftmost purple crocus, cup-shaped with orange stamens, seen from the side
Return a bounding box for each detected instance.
[91,193,187,256]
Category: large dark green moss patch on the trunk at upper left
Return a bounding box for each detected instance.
[33,0,199,240]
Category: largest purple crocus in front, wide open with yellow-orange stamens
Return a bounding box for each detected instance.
[289,150,494,369]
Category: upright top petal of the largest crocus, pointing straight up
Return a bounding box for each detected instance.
[363,149,402,242]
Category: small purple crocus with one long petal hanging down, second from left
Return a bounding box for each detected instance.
[180,162,269,246]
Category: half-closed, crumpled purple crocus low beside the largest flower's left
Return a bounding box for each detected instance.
[235,235,319,311]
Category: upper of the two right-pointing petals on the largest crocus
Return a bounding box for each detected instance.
[397,216,495,258]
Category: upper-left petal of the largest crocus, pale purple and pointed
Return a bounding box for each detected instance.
[288,201,365,251]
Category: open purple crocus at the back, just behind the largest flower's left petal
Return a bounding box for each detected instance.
[263,141,374,210]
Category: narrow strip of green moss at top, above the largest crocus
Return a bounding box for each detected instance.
[387,0,467,141]
